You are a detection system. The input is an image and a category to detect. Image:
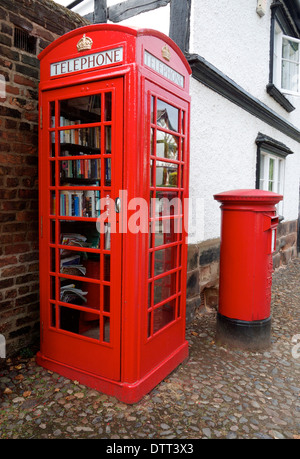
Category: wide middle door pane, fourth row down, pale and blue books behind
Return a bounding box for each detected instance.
[59,190,100,218]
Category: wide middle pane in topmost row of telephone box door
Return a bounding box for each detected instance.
[59,94,101,126]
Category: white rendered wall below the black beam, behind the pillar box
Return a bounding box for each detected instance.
[189,78,300,243]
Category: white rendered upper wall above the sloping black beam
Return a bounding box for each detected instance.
[190,0,300,131]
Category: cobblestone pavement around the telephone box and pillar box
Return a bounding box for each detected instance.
[0,259,300,440]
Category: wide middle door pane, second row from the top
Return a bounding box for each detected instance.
[59,126,100,149]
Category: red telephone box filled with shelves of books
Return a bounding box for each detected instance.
[37,24,191,403]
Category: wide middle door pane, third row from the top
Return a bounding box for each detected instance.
[59,159,101,186]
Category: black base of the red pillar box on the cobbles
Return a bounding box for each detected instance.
[216,313,271,351]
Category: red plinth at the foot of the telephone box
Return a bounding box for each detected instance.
[36,341,188,404]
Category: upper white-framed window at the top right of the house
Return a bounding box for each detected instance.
[273,21,300,95]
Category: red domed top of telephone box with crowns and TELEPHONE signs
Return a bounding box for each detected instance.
[38,24,191,92]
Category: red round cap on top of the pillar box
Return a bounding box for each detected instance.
[214,189,283,205]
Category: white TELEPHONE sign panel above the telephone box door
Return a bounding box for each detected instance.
[50,47,123,76]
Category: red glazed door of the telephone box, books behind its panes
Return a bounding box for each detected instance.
[40,78,123,381]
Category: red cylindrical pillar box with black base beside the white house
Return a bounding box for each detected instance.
[214,190,282,350]
